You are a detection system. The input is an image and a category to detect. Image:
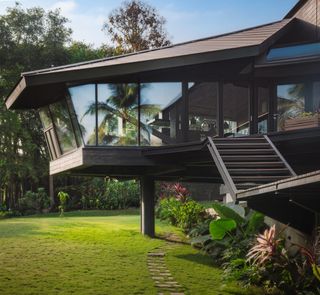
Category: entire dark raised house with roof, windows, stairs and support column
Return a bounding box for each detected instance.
[6,0,320,236]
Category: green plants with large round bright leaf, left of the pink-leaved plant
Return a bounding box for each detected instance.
[190,203,265,290]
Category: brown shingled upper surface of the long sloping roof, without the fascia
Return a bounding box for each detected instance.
[22,19,291,76]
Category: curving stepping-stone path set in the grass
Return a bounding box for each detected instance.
[147,243,184,295]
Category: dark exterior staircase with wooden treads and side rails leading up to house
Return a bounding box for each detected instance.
[208,135,296,199]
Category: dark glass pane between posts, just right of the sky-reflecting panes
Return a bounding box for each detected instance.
[188,82,218,141]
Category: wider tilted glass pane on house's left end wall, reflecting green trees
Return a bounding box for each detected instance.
[50,100,77,154]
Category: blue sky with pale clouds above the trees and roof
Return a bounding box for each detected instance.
[0,0,298,47]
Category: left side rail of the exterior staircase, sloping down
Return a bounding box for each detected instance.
[208,137,238,200]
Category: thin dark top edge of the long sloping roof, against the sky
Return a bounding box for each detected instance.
[21,18,291,76]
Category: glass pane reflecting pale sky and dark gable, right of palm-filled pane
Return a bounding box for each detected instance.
[140,83,182,146]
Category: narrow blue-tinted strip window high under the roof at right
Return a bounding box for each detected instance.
[267,43,320,61]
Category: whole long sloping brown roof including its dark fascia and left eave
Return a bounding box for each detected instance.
[6,19,295,108]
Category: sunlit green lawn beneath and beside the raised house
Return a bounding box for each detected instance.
[0,210,256,295]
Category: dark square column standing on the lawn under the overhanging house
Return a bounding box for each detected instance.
[140,176,155,238]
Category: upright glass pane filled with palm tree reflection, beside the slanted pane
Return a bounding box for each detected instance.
[97,83,139,146]
